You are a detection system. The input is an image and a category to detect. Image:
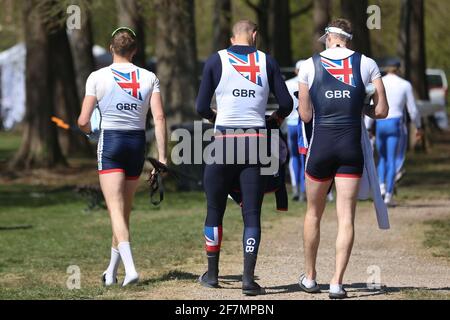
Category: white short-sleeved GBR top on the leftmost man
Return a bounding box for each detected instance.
[86,63,159,130]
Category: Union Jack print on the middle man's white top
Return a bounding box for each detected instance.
[227,50,262,87]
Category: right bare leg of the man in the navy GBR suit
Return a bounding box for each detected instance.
[330,178,360,284]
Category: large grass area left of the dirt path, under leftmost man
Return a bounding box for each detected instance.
[0,185,299,299]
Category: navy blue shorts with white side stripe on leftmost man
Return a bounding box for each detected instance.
[97,130,145,180]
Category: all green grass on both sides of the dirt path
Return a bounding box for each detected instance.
[0,129,450,299]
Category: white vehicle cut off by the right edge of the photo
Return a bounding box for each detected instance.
[426,69,449,130]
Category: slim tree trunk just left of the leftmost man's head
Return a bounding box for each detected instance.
[69,0,95,101]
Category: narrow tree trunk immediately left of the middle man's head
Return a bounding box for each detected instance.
[213,0,231,51]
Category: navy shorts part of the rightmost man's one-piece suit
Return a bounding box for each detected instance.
[306,126,364,181]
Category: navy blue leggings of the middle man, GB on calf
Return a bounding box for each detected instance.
[204,164,265,254]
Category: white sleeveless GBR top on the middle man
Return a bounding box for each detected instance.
[215,49,270,128]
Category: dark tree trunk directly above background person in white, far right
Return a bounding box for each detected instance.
[398,0,428,100]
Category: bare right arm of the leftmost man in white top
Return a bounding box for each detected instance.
[150,92,167,164]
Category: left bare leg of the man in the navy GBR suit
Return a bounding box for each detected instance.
[303,177,333,280]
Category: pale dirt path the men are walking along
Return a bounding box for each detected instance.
[139,200,450,299]
